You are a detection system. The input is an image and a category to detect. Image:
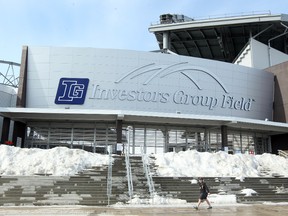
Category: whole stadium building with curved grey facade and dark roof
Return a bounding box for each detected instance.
[0,13,288,154]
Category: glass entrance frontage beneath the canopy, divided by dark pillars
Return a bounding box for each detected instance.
[24,122,271,155]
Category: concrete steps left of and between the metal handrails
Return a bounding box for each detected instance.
[0,156,149,206]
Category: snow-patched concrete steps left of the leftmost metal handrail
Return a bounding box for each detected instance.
[0,170,111,206]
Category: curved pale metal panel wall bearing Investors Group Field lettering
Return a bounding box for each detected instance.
[27,47,273,119]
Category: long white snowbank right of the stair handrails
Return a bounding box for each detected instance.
[155,150,288,179]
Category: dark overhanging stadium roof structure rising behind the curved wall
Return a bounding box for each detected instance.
[149,13,288,63]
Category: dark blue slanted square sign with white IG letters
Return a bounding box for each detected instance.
[55,78,89,104]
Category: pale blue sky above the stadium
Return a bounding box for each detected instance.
[0,0,288,63]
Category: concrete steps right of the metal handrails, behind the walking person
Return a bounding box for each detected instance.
[153,176,288,203]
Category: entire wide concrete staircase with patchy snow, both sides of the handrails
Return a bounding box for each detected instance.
[0,156,288,206]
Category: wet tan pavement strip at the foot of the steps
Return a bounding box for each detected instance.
[0,203,288,216]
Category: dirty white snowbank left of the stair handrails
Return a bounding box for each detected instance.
[0,145,109,176]
